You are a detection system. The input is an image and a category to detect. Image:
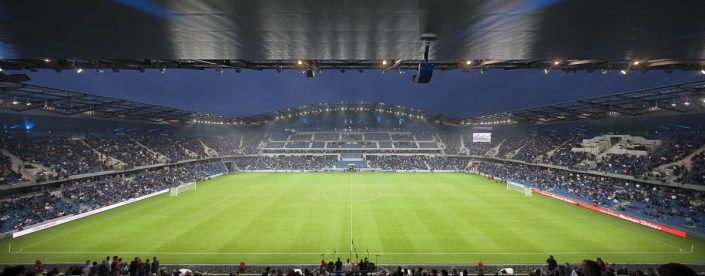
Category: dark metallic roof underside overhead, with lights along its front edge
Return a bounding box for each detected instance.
[0,0,705,71]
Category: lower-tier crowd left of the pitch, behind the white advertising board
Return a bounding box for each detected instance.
[0,162,225,233]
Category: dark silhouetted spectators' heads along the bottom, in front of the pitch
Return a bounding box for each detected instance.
[0,255,698,276]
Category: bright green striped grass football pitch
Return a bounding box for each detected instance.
[0,173,705,264]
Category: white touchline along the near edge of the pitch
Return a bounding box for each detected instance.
[9,251,693,255]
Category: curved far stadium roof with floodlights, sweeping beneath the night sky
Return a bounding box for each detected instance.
[0,81,705,126]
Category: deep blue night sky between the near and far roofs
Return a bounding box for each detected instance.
[19,69,705,117]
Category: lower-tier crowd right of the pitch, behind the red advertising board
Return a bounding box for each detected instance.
[477,162,705,233]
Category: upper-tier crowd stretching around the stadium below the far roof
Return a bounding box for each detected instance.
[5,131,705,184]
